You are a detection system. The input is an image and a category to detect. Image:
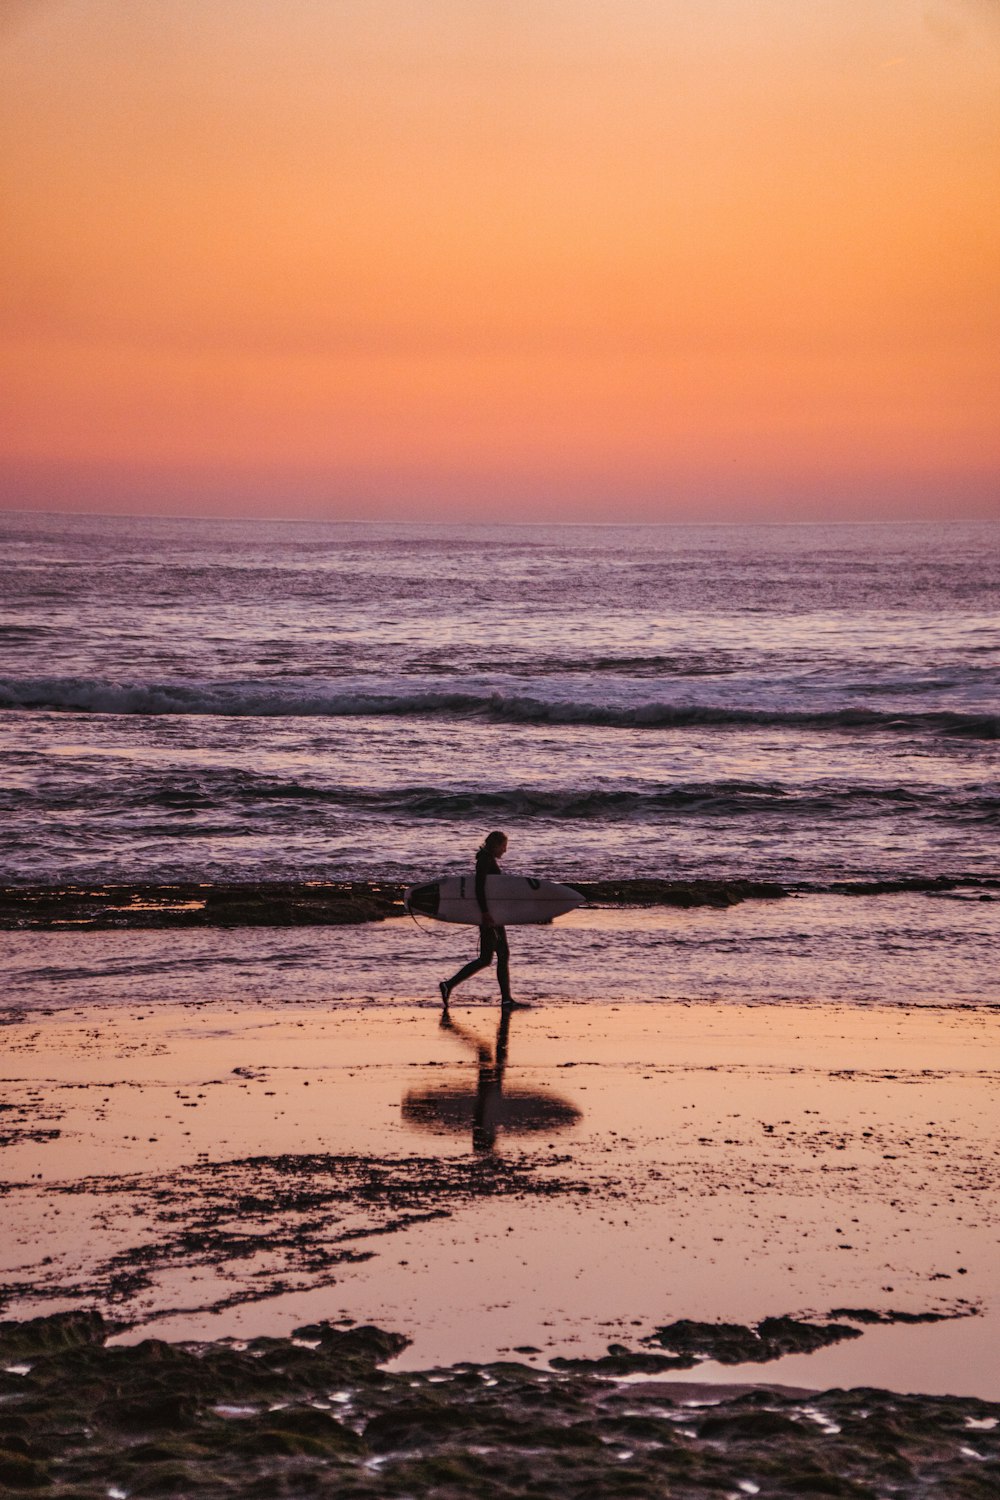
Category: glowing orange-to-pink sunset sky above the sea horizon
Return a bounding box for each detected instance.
[0,0,1000,521]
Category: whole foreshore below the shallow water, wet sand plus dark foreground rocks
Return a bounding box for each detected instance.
[0,966,1000,1496]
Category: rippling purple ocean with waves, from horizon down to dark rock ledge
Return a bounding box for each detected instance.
[0,513,1000,885]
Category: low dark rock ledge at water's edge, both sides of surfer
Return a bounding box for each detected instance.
[0,873,1000,932]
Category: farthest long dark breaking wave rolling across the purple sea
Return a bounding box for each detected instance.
[0,678,1000,740]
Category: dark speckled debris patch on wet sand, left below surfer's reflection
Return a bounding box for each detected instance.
[0,1154,592,1322]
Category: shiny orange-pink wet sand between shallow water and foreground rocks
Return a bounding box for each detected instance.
[0,998,1000,1400]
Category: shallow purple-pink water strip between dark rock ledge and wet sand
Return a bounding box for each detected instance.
[3,893,1000,1011]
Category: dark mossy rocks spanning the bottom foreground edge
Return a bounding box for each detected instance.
[0,1319,1000,1500]
